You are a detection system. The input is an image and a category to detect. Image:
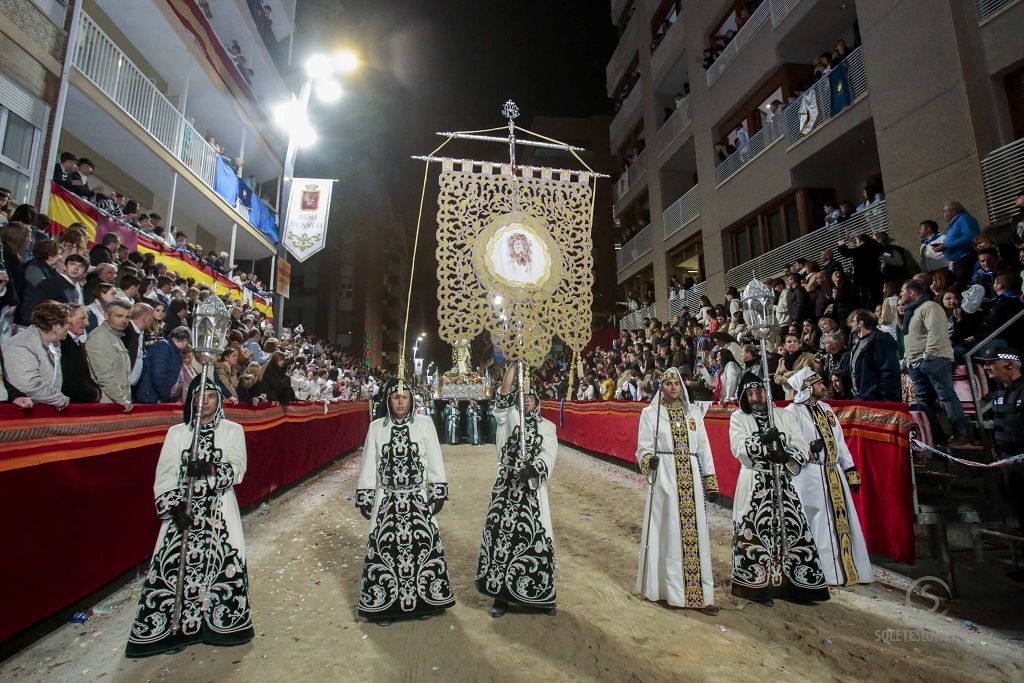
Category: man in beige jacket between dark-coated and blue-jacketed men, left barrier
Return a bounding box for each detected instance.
[85,299,132,413]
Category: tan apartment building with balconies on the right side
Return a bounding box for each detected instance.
[606,0,1024,326]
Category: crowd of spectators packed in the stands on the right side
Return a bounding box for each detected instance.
[536,196,1024,454]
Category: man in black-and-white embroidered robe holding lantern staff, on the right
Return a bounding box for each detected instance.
[729,372,828,605]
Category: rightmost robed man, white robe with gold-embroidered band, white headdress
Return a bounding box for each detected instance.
[785,368,874,586]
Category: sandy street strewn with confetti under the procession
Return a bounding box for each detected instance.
[0,445,1024,683]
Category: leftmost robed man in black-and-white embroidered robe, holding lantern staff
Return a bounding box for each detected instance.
[125,376,255,657]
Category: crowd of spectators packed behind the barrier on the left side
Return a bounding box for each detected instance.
[0,183,387,412]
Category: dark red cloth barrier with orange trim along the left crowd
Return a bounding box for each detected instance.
[0,401,370,641]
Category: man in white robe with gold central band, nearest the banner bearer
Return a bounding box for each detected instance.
[637,368,718,614]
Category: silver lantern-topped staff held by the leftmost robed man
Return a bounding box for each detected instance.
[171,292,230,634]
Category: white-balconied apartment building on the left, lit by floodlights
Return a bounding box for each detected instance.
[0,0,296,301]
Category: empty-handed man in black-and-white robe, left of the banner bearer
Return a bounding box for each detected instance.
[355,380,455,626]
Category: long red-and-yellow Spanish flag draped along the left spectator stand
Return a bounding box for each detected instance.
[49,182,273,321]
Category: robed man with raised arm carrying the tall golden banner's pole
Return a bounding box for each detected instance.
[476,362,558,617]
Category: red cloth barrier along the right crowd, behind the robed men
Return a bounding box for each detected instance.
[542,400,913,562]
